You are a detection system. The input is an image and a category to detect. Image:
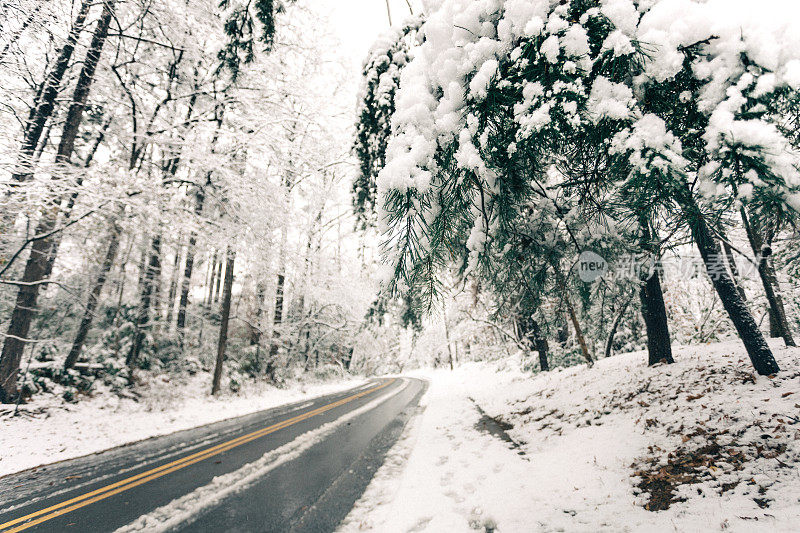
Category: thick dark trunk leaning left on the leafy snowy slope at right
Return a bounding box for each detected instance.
[683,197,780,375]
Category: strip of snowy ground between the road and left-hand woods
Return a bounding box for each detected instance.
[0,374,365,476]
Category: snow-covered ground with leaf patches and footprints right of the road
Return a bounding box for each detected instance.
[341,342,800,532]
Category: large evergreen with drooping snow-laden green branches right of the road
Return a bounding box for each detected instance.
[378,0,799,374]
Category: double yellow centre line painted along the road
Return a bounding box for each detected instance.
[0,379,395,533]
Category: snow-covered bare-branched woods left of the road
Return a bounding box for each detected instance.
[0,1,388,401]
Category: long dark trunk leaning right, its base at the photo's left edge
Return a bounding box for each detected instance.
[0,2,113,403]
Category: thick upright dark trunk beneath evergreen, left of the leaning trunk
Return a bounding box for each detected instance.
[639,218,675,365]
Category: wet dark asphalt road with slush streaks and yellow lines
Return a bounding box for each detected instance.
[0,378,426,533]
